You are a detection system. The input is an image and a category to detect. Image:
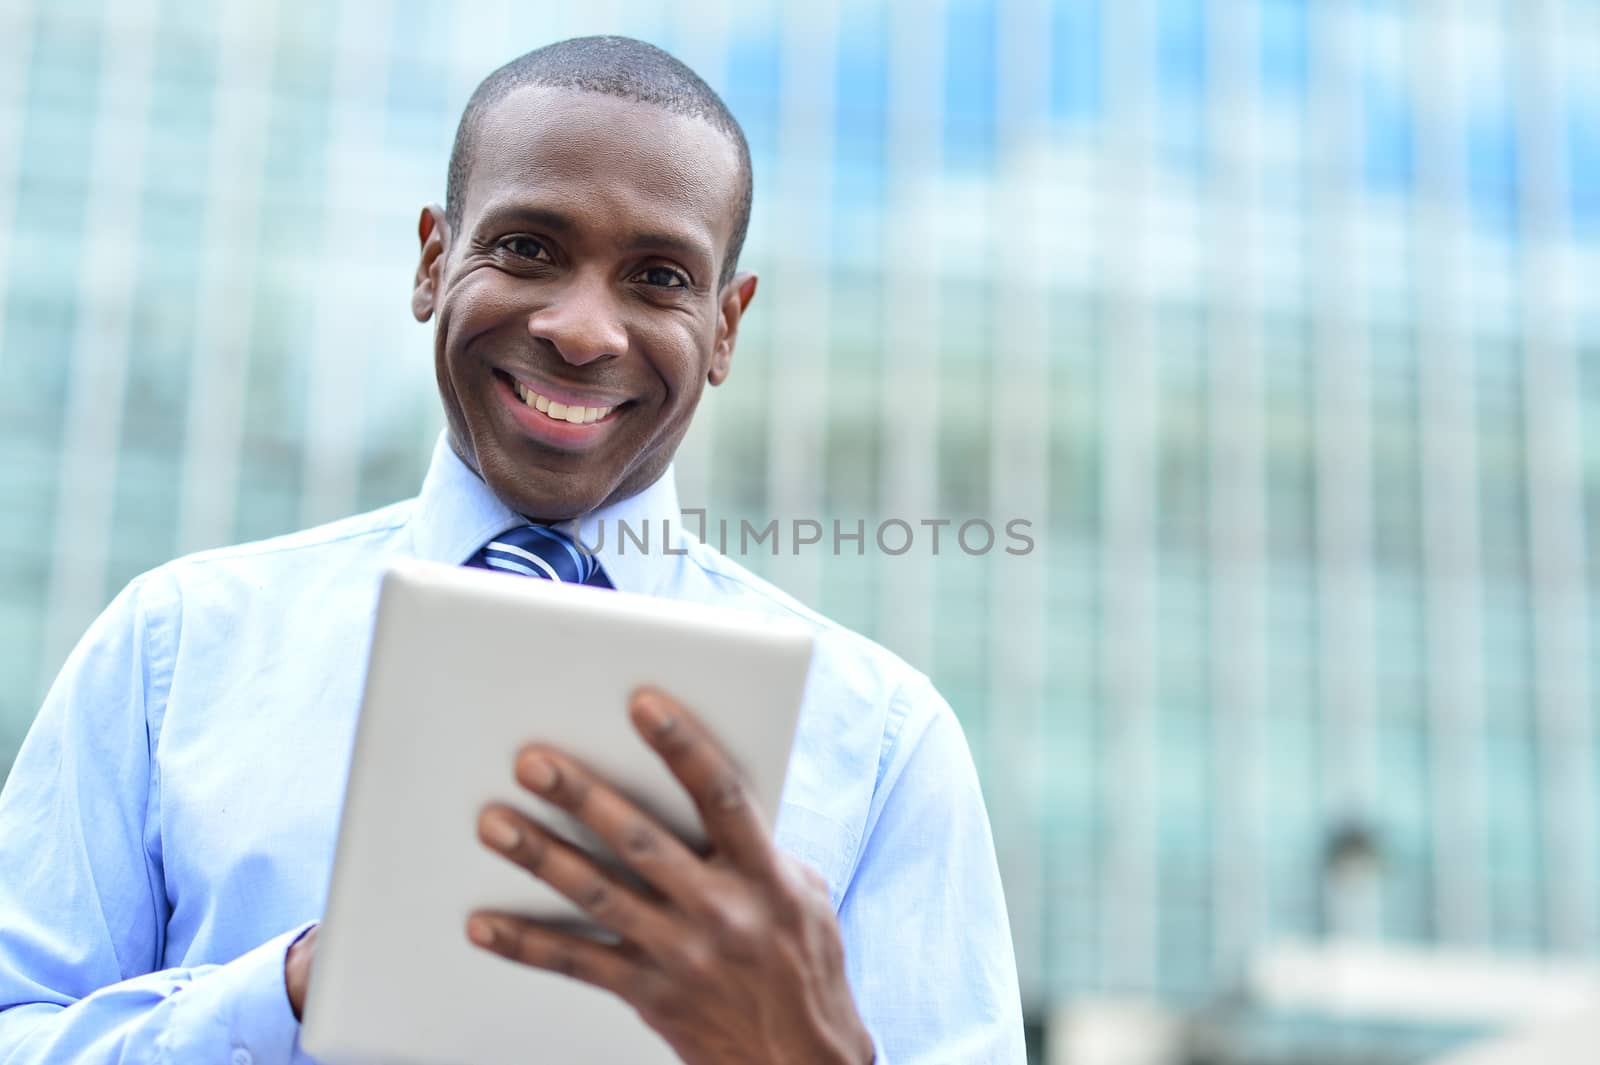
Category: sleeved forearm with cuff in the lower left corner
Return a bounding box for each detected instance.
[0,929,312,1065]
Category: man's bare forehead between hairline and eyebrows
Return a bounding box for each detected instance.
[462,86,739,251]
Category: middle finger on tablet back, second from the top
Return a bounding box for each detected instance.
[517,747,707,910]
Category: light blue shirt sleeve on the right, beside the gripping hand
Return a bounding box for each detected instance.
[838,678,1027,1065]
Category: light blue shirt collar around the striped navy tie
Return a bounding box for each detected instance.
[410,433,682,595]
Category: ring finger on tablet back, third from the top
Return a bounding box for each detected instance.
[478,804,674,950]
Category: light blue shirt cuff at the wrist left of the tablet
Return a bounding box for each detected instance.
[172,921,315,1065]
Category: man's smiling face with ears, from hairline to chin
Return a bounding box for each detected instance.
[413,88,755,521]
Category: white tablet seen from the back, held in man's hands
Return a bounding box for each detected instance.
[301,563,811,1065]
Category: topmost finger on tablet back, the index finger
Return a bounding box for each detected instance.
[632,688,778,876]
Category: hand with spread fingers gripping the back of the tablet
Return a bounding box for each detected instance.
[467,691,872,1065]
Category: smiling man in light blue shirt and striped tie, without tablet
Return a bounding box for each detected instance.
[0,38,1022,1065]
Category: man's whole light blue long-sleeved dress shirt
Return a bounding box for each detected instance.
[0,440,1024,1065]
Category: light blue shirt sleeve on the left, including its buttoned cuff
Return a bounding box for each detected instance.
[0,579,310,1065]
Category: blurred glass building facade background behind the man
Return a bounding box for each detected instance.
[0,0,1600,1065]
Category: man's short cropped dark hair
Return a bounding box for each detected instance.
[445,37,754,285]
